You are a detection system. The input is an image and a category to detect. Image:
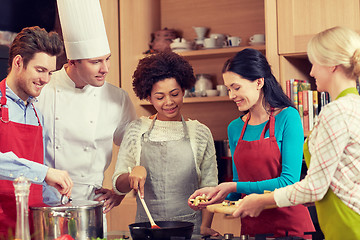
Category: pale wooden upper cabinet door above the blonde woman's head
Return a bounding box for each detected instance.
[277,0,360,54]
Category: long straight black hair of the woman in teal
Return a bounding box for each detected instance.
[222,48,294,108]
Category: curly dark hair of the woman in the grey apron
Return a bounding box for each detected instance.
[133,51,196,100]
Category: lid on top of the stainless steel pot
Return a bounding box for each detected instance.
[30,200,104,210]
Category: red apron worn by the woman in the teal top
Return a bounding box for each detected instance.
[234,112,315,238]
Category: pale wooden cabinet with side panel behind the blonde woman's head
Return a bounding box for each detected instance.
[265,0,360,86]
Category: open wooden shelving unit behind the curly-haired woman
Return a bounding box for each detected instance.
[119,0,265,140]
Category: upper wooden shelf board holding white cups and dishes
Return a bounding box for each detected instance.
[178,45,265,59]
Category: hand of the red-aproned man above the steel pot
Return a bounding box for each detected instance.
[45,168,74,197]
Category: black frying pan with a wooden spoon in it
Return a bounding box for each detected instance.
[129,221,194,240]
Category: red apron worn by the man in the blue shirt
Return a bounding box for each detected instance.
[0,80,44,239]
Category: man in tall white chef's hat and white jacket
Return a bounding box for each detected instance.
[38,0,136,213]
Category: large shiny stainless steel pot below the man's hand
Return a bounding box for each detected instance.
[30,201,104,240]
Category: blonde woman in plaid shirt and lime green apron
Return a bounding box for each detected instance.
[233,27,360,240]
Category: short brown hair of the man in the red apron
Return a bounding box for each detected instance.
[8,26,64,72]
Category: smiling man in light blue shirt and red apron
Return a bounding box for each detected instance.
[0,27,72,239]
